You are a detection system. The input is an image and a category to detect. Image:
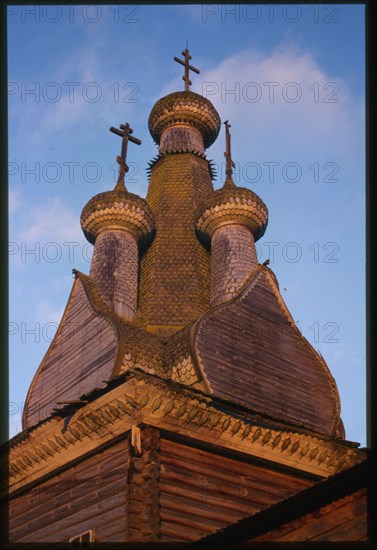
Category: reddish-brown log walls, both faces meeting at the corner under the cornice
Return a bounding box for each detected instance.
[10,427,334,542]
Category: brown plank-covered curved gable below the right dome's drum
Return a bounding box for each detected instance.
[196,269,339,434]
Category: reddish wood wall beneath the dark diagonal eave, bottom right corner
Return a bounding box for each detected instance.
[253,489,367,542]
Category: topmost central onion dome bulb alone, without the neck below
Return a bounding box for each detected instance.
[148,90,221,149]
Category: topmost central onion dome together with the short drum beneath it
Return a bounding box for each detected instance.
[148,91,221,153]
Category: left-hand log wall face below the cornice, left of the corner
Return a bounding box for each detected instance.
[9,439,129,542]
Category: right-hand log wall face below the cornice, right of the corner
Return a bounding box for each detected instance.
[160,439,311,541]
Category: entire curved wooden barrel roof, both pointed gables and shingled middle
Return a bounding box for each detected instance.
[23,265,344,437]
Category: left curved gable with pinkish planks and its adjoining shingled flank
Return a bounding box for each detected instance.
[23,272,164,429]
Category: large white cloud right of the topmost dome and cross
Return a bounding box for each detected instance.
[194,44,363,160]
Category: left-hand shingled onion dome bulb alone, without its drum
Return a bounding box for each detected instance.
[80,182,155,249]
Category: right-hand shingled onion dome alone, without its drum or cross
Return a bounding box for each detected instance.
[195,182,268,248]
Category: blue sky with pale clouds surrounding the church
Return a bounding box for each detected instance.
[8,4,366,445]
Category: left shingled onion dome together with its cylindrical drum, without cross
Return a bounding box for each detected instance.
[80,187,155,321]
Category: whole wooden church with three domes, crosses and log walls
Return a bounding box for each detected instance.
[3,48,368,546]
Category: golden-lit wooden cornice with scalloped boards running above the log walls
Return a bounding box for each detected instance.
[2,371,365,493]
